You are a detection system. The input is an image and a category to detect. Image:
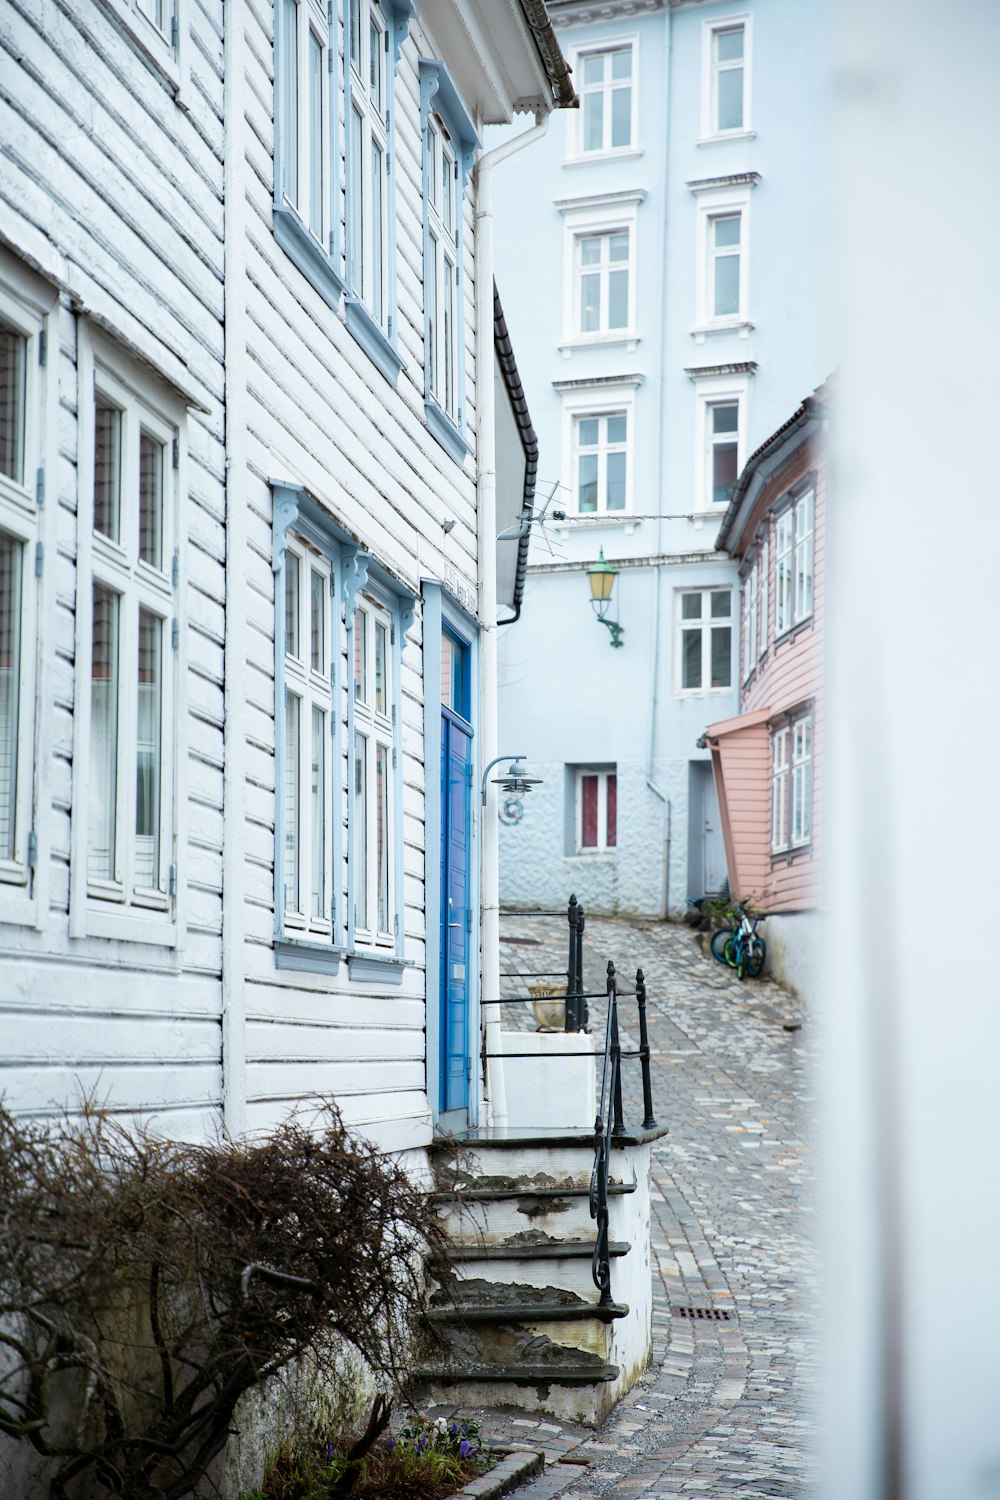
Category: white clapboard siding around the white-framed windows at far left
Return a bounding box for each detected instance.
[0,0,225,1137]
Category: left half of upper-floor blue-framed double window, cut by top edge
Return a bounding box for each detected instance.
[273,0,343,308]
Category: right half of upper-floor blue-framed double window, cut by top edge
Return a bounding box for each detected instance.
[343,0,412,384]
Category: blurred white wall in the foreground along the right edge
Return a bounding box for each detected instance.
[822,0,1000,1500]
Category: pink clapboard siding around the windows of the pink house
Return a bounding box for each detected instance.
[708,429,826,912]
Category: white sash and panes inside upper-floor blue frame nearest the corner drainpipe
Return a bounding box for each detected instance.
[424,116,460,422]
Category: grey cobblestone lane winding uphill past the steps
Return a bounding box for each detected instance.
[458,915,816,1500]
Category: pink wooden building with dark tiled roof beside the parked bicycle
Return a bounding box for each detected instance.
[706,387,826,935]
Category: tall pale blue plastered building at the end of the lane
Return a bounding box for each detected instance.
[498,0,834,917]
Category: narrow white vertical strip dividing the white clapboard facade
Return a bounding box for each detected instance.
[222,0,249,1139]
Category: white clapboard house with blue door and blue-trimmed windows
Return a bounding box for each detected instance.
[0,0,573,1151]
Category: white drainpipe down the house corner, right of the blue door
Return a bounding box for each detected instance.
[475,113,549,1125]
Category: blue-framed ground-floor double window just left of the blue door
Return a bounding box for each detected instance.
[271,485,415,983]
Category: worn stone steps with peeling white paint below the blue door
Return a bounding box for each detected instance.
[417,1128,663,1425]
